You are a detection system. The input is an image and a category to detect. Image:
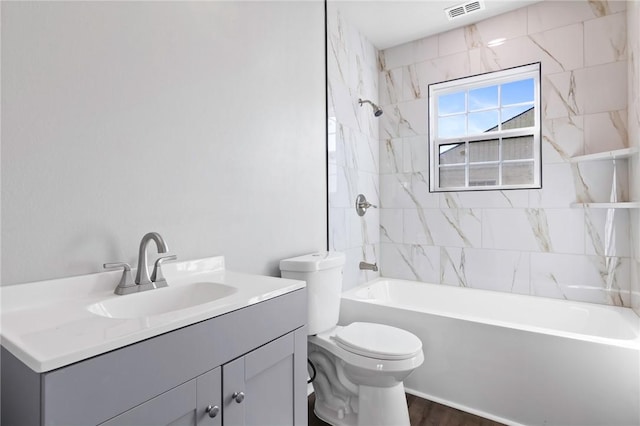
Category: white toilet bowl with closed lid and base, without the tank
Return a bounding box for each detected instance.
[308,322,424,426]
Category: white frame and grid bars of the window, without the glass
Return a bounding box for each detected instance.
[429,62,542,192]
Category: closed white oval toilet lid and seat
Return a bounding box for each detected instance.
[332,322,422,360]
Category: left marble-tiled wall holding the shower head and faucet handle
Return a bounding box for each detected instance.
[327,2,380,290]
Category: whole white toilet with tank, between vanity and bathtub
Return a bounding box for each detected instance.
[280,252,424,426]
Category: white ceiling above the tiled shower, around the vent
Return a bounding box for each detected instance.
[330,0,540,50]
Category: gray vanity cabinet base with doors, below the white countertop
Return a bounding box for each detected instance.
[1,289,307,426]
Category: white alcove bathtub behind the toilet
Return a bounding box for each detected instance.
[340,278,640,426]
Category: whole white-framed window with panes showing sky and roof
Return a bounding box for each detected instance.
[429,63,542,192]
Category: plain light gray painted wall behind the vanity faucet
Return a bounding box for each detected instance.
[1,1,327,284]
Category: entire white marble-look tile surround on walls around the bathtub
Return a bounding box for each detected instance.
[328,1,640,312]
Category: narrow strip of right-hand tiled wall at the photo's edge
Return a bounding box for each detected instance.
[627,1,640,315]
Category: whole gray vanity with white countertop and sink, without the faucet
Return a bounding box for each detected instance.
[0,257,307,426]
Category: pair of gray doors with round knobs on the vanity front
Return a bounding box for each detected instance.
[101,333,295,426]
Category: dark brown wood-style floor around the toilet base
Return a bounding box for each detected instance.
[309,394,504,426]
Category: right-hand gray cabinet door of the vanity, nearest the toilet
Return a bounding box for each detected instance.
[222,333,296,426]
